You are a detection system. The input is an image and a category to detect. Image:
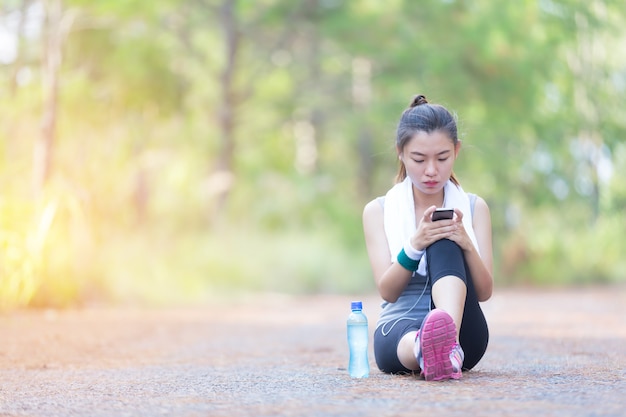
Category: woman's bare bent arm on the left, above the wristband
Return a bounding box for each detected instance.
[363,200,412,303]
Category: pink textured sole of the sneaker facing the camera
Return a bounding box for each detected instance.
[420,309,459,381]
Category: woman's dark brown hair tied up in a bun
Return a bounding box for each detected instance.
[396,95,459,185]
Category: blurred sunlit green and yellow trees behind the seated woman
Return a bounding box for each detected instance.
[0,0,626,309]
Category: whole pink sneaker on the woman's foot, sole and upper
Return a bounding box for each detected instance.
[415,309,464,381]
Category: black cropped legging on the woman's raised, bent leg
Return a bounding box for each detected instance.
[426,239,489,369]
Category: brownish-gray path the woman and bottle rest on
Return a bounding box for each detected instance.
[0,287,626,417]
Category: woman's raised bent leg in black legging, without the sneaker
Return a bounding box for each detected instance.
[426,239,489,369]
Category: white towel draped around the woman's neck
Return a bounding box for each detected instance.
[384,177,480,275]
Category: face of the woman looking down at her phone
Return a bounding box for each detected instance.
[399,130,461,194]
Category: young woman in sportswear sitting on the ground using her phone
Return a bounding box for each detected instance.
[363,95,493,381]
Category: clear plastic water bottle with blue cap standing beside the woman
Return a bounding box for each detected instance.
[348,301,370,378]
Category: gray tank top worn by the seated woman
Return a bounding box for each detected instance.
[376,193,476,336]
